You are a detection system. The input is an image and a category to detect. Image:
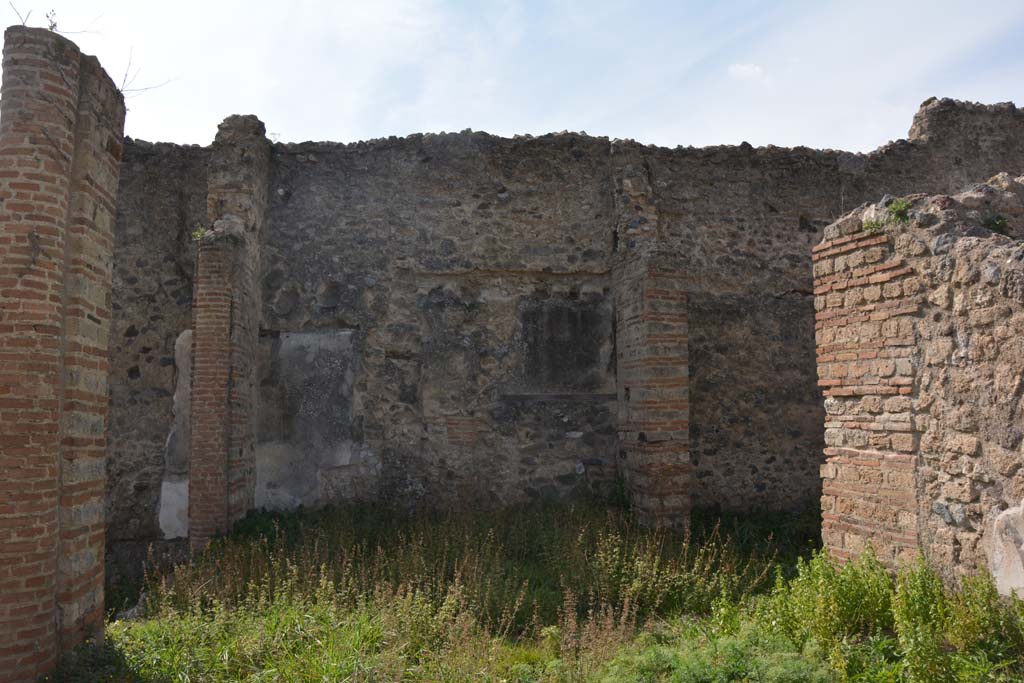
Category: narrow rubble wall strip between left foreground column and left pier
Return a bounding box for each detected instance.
[106,140,210,577]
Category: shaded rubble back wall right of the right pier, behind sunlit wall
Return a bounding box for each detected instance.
[637,99,1024,511]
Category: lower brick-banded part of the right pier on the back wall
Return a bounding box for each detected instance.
[615,255,692,526]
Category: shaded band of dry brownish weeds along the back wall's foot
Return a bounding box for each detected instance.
[150,505,792,635]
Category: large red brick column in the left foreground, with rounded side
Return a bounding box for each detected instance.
[0,27,125,682]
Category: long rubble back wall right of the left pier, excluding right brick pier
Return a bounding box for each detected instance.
[101,100,1024,557]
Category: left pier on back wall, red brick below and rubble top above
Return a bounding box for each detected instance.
[188,116,270,549]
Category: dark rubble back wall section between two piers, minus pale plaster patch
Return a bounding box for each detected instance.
[263,134,616,506]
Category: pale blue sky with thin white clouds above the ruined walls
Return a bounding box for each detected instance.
[8,0,1024,152]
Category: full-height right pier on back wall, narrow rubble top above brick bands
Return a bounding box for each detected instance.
[612,160,693,527]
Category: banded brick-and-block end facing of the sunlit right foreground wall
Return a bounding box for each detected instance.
[813,218,922,566]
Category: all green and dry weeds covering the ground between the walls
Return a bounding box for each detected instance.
[53,505,1024,683]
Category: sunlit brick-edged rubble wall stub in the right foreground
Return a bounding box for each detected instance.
[814,174,1024,590]
